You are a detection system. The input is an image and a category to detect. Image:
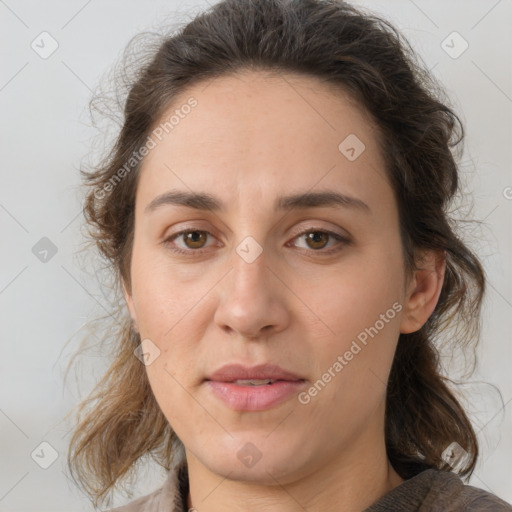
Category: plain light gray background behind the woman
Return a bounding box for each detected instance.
[0,0,512,512]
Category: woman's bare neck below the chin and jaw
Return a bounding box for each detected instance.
[187,406,403,512]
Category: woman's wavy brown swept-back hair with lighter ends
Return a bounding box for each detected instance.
[68,0,485,504]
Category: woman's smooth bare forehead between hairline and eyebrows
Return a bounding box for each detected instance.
[138,71,389,210]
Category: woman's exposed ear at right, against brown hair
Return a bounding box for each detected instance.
[400,251,446,334]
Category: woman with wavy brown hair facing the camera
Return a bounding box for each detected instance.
[69,0,512,512]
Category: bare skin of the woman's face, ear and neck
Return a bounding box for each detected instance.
[125,71,444,512]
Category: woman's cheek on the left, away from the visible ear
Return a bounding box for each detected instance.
[132,250,215,388]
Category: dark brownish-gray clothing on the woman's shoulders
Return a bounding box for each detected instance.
[108,460,512,512]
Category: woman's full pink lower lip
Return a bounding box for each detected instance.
[206,380,305,411]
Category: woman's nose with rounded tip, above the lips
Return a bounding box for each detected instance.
[214,247,290,339]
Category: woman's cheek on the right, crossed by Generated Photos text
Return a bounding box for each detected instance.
[299,240,403,388]
